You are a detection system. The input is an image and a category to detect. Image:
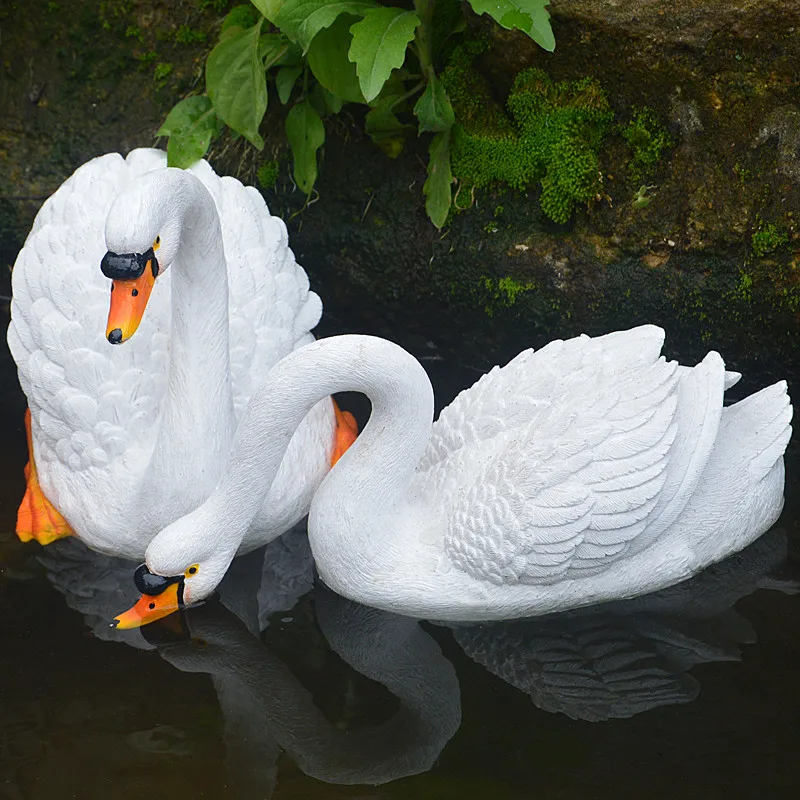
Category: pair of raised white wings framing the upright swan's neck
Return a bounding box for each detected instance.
[8,148,321,478]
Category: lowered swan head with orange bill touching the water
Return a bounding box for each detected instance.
[112,507,236,629]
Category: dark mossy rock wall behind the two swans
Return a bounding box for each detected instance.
[0,0,800,394]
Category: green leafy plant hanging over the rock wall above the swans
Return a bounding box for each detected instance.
[159,0,555,227]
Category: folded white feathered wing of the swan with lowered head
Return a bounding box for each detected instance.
[434,329,725,584]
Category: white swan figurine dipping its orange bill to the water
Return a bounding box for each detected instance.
[117,325,792,625]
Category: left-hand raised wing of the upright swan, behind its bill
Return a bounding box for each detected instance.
[8,149,169,479]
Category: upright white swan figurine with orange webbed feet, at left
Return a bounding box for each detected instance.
[8,149,354,560]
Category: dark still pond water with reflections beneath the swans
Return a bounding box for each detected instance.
[0,296,800,800]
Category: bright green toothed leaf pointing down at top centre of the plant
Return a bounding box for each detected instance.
[348,6,420,103]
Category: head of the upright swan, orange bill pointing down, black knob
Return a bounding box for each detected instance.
[100,169,186,344]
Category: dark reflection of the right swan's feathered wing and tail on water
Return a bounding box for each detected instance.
[452,530,798,722]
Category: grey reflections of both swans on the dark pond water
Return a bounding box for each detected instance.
[40,530,797,798]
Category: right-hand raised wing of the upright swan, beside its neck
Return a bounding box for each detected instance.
[190,161,322,417]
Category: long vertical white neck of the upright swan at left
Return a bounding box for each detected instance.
[147,169,235,515]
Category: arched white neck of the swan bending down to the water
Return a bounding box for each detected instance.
[209,335,433,548]
